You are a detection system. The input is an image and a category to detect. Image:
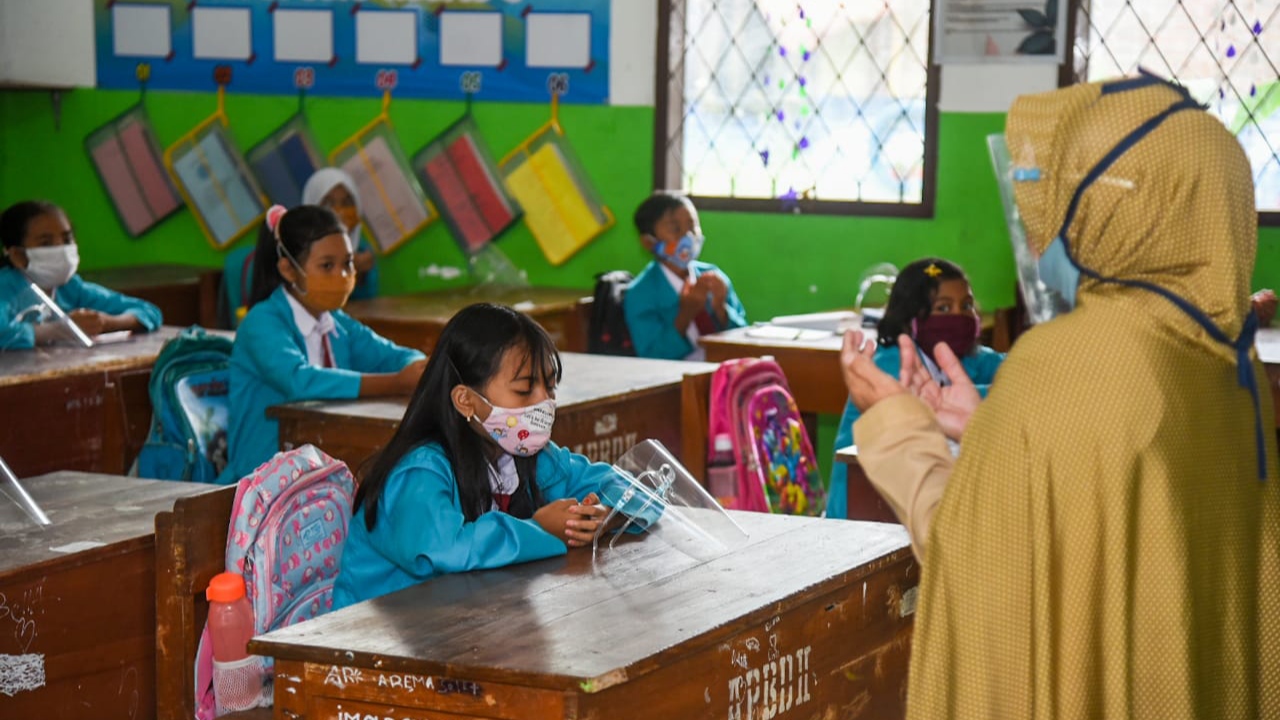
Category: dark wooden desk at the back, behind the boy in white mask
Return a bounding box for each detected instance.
[81,265,223,328]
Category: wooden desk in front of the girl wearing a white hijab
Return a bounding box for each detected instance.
[346,284,591,354]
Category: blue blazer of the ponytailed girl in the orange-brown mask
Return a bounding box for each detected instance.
[226,287,424,483]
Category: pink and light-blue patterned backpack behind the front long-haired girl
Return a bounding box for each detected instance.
[196,445,356,720]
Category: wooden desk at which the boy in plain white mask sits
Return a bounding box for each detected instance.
[0,325,193,477]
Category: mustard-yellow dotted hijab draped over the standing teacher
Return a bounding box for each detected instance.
[908,81,1280,720]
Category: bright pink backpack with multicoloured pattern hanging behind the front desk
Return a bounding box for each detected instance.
[708,357,827,515]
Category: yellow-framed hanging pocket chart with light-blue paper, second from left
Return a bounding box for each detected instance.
[164,87,266,250]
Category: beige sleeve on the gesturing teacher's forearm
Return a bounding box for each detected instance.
[854,393,955,562]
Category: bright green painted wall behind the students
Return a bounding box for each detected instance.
[0,90,1280,319]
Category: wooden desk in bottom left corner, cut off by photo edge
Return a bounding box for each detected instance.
[0,471,218,719]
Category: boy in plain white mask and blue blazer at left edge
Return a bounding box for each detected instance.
[0,200,160,350]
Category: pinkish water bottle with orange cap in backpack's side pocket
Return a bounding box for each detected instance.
[205,573,265,715]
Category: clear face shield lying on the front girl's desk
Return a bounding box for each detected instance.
[591,439,748,561]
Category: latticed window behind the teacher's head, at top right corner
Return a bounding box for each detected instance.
[1064,0,1280,217]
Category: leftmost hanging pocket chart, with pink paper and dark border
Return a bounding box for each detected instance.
[84,104,182,237]
